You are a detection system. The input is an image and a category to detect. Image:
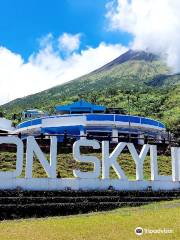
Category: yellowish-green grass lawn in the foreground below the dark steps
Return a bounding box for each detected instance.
[0,200,180,240]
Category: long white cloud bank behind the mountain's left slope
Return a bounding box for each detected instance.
[0,34,127,104]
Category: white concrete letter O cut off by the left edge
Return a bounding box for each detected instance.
[0,137,23,178]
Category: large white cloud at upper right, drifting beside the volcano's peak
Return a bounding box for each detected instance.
[107,0,180,72]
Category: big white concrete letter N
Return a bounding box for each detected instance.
[26,136,57,178]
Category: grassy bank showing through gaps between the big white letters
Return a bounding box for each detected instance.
[0,152,171,179]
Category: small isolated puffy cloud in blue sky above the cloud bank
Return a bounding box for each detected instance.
[58,33,81,53]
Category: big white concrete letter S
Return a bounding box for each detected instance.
[73,139,101,178]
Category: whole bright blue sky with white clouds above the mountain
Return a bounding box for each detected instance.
[0,0,180,104]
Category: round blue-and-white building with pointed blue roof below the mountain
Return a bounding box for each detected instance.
[14,99,167,144]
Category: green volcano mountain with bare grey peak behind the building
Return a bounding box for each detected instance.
[1,50,180,129]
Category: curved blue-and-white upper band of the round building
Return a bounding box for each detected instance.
[16,114,165,137]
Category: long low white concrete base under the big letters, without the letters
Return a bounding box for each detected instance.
[0,178,180,191]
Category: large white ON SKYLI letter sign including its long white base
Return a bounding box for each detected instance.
[0,136,180,190]
